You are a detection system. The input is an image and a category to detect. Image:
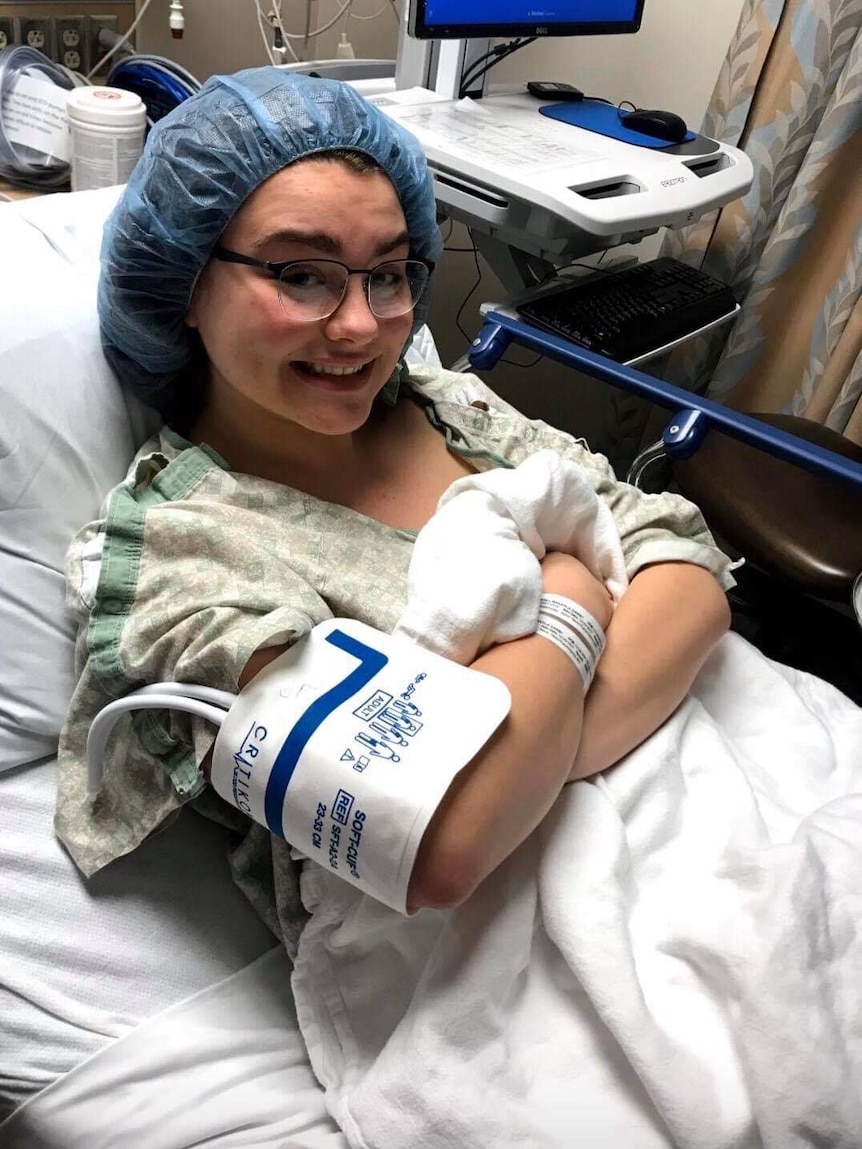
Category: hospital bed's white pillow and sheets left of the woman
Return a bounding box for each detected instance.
[0,188,346,1149]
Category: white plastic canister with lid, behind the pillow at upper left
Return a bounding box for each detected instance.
[66,87,147,192]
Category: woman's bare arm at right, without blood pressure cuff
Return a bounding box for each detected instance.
[569,562,730,781]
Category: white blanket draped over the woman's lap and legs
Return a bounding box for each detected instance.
[293,452,862,1149]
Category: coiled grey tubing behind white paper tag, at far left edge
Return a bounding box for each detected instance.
[0,45,85,191]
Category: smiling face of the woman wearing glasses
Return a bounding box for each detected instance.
[186,159,413,447]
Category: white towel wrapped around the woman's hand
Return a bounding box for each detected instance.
[395,450,628,665]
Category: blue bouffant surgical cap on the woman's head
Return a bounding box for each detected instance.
[99,68,442,414]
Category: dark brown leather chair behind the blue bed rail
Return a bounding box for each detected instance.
[629,414,862,704]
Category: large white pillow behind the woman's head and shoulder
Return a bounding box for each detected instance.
[0,187,157,770]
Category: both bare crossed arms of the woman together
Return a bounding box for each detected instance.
[234,554,729,909]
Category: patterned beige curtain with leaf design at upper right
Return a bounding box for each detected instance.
[651,0,862,444]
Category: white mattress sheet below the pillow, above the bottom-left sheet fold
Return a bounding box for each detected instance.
[0,759,277,1116]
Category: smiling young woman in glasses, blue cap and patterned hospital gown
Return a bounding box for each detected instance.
[57,68,731,914]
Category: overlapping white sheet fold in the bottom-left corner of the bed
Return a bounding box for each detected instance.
[0,949,347,1149]
